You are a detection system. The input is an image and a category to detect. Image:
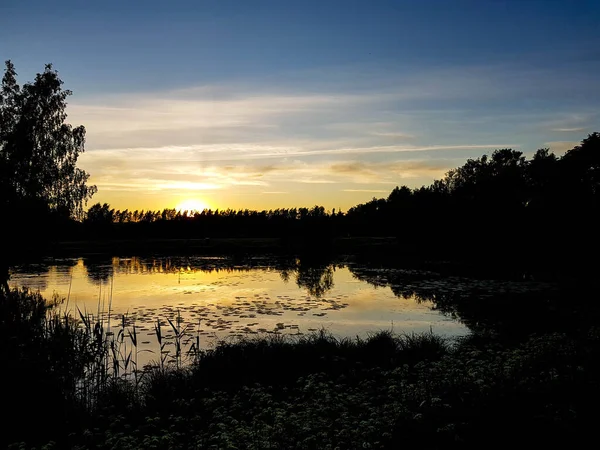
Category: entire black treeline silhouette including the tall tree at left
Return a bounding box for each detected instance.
[0,61,600,270]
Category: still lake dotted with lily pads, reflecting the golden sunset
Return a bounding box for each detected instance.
[10,256,549,368]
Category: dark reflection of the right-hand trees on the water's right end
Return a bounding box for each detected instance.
[350,266,599,338]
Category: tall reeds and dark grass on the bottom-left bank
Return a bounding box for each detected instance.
[0,289,200,447]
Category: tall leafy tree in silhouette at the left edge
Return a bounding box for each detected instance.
[0,61,97,219]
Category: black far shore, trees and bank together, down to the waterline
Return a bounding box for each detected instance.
[4,133,600,284]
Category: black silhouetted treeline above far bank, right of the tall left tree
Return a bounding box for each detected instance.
[80,133,600,258]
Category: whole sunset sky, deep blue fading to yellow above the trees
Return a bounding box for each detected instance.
[0,0,600,210]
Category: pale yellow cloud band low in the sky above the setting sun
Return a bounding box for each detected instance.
[81,147,456,196]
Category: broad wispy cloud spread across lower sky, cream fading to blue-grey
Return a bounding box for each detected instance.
[68,58,595,211]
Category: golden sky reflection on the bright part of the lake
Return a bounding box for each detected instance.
[11,257,464,335]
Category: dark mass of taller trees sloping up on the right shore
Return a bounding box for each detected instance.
[346,133,600,258]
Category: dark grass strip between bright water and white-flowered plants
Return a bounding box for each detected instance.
[183,329,451,389]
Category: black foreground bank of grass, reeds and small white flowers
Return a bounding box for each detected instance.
[0,290,600,449]
